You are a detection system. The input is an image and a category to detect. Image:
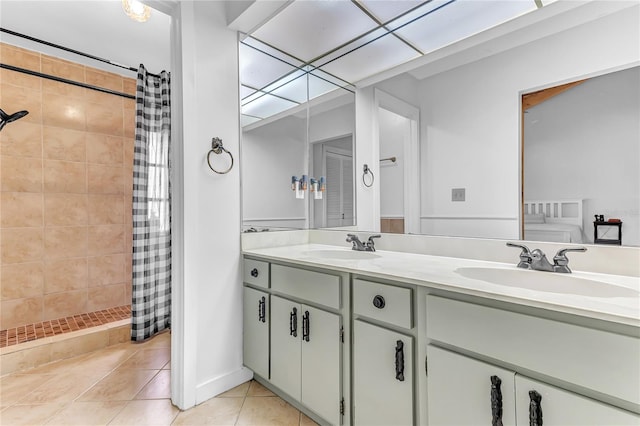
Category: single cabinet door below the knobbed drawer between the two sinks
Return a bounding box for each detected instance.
[353,320,413,426]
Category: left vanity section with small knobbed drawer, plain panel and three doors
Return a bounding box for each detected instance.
[244,258,350,425]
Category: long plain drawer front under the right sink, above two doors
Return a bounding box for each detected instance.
[427,296,640,404]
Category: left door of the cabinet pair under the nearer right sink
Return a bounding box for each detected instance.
[427,345,525,426]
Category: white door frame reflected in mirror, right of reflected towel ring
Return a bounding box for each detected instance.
[373,88,420,234]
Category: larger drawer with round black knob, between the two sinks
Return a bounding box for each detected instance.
[353,278,413,328]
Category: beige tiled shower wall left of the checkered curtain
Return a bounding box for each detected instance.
[0,43,135,329]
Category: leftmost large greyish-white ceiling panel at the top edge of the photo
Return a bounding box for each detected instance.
[253,1,377,61]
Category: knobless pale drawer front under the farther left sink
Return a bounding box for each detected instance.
[271,265,340,309]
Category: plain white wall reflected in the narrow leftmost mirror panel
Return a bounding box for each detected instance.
[242,116,308,228]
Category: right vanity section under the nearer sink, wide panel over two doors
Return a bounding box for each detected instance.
[427,295,640,426]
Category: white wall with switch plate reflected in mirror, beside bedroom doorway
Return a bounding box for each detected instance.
[420,6,640,238]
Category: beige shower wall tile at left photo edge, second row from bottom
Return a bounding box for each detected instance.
[0,262,44,300]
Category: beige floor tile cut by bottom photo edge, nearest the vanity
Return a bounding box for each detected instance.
[236,396,300,426]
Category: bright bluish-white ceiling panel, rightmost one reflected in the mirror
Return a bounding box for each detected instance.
[389,0,536,53]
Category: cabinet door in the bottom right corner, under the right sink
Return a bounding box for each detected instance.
[516,375,640,426]
